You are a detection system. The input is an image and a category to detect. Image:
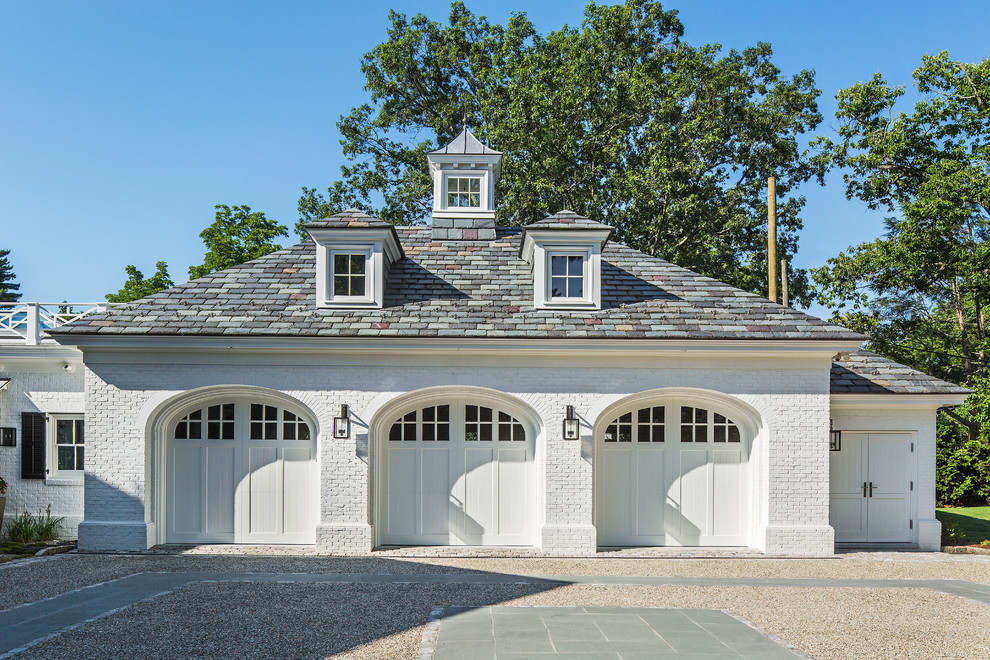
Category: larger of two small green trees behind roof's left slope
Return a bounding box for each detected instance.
[189,204,289,279]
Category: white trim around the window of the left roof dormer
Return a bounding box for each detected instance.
[308,227,402,309]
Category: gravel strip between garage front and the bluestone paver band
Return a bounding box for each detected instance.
[0,552,990,607]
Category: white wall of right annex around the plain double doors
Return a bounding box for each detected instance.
[832,402,942,551]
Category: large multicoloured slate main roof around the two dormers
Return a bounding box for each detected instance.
[52,226,864,340]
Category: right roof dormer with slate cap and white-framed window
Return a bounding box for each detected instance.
[519,211,612,309]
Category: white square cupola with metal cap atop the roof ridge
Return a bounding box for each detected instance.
[426,126,502,238]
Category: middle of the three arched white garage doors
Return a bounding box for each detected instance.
[379,399,536,545]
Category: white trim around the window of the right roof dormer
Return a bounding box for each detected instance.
[522,229,610,310]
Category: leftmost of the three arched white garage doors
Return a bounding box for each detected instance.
[165,399,318,543]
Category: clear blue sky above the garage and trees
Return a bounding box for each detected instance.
[0,0,990,314]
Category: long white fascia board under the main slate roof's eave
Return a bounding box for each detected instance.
[60,335,868,358]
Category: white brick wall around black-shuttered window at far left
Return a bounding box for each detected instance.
[0,349,84,538]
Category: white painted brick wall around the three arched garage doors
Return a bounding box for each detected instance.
[80,351,833,554]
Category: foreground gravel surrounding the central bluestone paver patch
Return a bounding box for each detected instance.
[17,583,990,659]
